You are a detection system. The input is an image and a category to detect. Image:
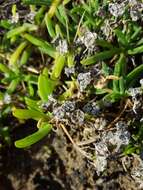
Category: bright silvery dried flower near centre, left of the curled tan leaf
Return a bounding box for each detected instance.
[77,72,92,92]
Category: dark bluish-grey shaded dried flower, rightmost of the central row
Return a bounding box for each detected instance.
[83,102,101,115]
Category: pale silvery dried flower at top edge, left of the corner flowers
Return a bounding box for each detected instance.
[109,3,125,17]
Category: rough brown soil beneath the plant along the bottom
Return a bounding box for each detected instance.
[0,121,138,190]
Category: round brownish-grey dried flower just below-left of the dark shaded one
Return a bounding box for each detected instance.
[71,109,84,125]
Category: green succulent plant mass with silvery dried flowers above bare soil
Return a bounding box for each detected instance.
[0,0,143,172]
